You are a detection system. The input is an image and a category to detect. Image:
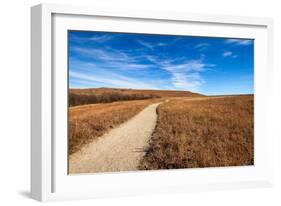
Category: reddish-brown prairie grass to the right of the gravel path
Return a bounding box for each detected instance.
[140,95,254,170]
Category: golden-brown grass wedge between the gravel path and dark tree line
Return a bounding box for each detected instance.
[69,100,159,154]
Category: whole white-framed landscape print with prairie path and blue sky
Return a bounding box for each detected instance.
[31,4,273,201]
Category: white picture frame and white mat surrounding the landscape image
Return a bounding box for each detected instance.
[31,4,274,201]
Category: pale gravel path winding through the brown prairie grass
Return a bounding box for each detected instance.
[69,103,160,174]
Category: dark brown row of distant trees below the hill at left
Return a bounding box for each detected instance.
[68,92,159,106]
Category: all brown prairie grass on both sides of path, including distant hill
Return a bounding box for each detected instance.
[69,88,254,170]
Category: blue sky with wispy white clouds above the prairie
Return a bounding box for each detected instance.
[68,31,254,95]
